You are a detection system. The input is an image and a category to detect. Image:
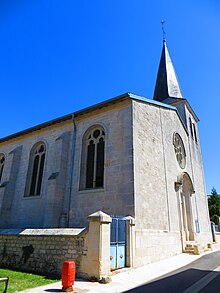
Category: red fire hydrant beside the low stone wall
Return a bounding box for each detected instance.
[62,260,76,292]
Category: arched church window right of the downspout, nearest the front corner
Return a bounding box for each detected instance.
[81,127,105,189]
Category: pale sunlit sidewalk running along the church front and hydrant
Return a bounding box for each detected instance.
[21,243,220,293]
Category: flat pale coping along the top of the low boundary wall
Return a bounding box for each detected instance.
[0,228,87,236]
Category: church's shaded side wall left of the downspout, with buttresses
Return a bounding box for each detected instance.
[0,121,73,229]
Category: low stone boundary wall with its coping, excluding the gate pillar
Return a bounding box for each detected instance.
[0,229,87,276]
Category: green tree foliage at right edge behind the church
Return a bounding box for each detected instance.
[208,187,220,225]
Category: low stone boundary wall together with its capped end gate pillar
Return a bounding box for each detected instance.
[0,211,111,280]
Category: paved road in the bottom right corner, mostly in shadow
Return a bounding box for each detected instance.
[127,251,220,293]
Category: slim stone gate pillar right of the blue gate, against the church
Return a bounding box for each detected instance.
[126,216,135,267]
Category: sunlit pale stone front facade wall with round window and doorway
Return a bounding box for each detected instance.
[133,101,211,266]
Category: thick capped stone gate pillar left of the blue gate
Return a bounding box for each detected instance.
[84,211,112,280]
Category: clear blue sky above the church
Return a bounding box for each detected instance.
[0,0,220,193]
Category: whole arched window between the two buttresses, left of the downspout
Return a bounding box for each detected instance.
[26,143,46,196]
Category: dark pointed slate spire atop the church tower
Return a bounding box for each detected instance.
[154,38,183,102]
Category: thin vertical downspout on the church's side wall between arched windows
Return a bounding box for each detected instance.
[67,114,76,228]
